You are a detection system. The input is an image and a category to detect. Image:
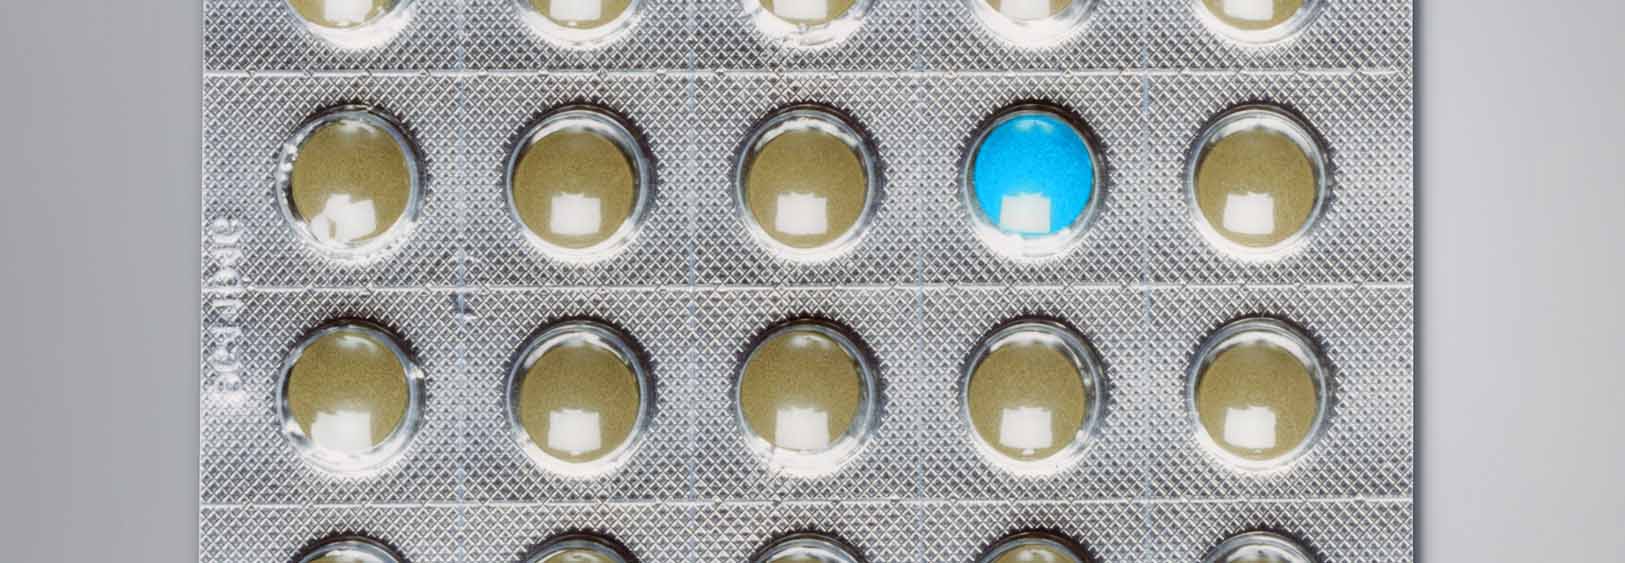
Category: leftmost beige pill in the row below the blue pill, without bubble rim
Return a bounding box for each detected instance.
[284,325,411,454]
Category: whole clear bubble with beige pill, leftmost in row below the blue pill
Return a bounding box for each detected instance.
[278,321,424,474]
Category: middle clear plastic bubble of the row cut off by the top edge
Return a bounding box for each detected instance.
[741,0,874,47]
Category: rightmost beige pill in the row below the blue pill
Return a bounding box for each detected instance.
[1196,323,1321,462]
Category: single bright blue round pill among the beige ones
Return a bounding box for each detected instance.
[970,112,1095,236]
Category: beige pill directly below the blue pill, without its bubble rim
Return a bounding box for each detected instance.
[965,330,1089,460]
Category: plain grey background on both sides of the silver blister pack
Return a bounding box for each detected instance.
[0,0,1625,563]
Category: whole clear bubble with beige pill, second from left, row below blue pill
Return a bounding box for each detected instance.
[507,321,655,477]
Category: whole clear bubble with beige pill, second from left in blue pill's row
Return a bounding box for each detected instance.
[507,106,655,262]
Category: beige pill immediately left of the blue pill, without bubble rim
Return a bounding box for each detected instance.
[743,117,869,249]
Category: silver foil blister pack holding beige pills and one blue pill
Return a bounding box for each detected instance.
[200,0,1415,563]
